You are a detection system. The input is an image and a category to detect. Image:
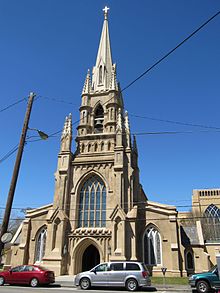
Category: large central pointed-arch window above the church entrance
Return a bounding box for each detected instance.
[78,176,106,227]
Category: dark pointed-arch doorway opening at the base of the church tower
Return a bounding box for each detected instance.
[82,244,100,272]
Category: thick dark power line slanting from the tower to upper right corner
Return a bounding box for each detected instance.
[121,11,220,92]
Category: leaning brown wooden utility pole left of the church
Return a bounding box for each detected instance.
[0,93,35,264]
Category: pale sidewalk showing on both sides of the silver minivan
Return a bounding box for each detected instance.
[55,275,192,292]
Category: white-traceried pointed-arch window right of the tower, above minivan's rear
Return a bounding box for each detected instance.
[143,227,162,266]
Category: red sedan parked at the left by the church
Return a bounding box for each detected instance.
[0,265,55,287]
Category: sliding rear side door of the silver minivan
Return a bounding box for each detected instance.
[108,262,125,286]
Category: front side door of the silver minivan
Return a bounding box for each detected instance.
[91,263,108,286]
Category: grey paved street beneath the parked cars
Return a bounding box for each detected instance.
[1,285,192,293]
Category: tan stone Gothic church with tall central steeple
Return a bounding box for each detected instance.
[7,7,220,276]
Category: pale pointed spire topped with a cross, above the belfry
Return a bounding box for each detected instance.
[92,6,113,92]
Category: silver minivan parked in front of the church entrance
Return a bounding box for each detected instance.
[75,261,151,291]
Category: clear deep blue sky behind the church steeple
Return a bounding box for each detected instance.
[0,0,220,214]
